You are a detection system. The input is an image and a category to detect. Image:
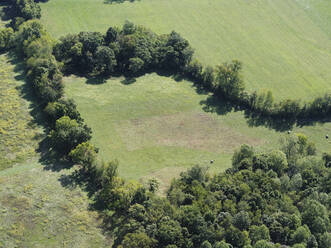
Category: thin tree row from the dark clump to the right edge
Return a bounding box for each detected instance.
[183,60,331,120]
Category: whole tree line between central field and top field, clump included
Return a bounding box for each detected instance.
[54,22,331,125]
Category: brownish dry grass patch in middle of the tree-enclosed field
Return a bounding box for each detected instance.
[117,112,262,152]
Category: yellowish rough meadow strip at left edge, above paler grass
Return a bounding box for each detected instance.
[0,54,42,171]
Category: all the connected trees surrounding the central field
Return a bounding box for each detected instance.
[0,0,331,248]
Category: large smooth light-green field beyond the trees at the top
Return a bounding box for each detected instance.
[41,0,331,99]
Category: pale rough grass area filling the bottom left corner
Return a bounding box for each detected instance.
[0,160,111,248]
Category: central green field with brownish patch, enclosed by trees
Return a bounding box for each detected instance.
[65,74,331,188]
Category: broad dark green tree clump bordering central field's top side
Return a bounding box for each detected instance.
[54,22,193,76]
